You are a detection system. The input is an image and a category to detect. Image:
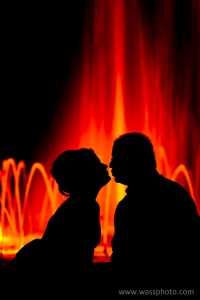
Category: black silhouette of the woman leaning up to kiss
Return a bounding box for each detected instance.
[3,148,111,294]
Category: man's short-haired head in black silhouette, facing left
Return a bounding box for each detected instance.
[109,132,156,185]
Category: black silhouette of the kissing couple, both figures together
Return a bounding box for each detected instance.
[1,132,200,299]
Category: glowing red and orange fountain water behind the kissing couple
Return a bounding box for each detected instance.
[0,0,200,262]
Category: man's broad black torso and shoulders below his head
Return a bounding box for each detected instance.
[111,173,200,288]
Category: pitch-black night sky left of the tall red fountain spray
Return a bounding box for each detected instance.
[0,0,86,162]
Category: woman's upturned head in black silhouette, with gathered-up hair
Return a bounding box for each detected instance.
[50,148,110,196]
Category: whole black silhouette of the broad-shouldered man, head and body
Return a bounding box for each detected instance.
[109,132,200,288]
